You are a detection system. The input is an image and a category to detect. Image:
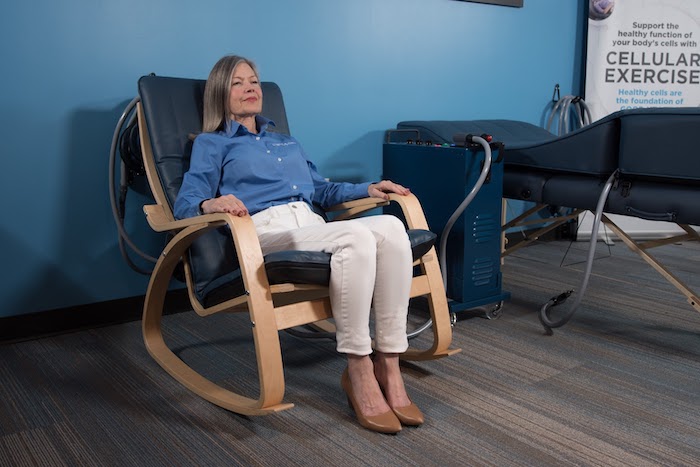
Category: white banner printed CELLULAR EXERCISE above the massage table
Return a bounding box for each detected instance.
[585,0,700,120]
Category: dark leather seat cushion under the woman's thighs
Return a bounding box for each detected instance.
[203,229,437,307]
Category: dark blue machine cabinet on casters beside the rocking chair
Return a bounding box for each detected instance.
[383,130,510,321]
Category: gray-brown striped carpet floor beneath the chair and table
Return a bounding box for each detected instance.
[0,241,700,466]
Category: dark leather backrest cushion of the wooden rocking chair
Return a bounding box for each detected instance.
[138,76,289,300]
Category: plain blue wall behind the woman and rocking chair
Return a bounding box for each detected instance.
[0,0,585,316]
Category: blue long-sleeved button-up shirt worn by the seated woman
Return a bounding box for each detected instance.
[174,117,369,219]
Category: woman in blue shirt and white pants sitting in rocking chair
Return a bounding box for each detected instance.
[174,55,423,433]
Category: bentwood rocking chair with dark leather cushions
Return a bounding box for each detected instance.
[137,76,459,415]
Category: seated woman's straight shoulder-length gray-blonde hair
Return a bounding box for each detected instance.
[202,55,259,133]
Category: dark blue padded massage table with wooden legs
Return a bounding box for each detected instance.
[396,107,700,334]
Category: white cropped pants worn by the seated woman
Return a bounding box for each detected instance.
[253,202,413,355]
